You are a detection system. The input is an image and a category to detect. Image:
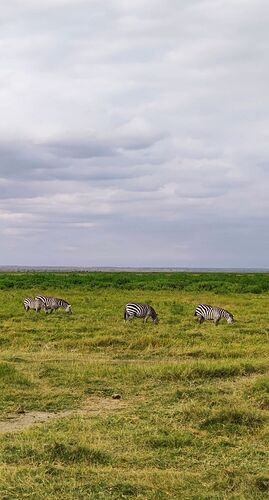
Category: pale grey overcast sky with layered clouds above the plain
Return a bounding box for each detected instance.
[0,0,269,267]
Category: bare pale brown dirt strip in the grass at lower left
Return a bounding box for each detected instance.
[0,398,127,433]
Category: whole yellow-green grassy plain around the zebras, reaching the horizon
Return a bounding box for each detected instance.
[0,273,269,500]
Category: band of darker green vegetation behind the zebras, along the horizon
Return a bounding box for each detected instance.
[0,272,269,294]
